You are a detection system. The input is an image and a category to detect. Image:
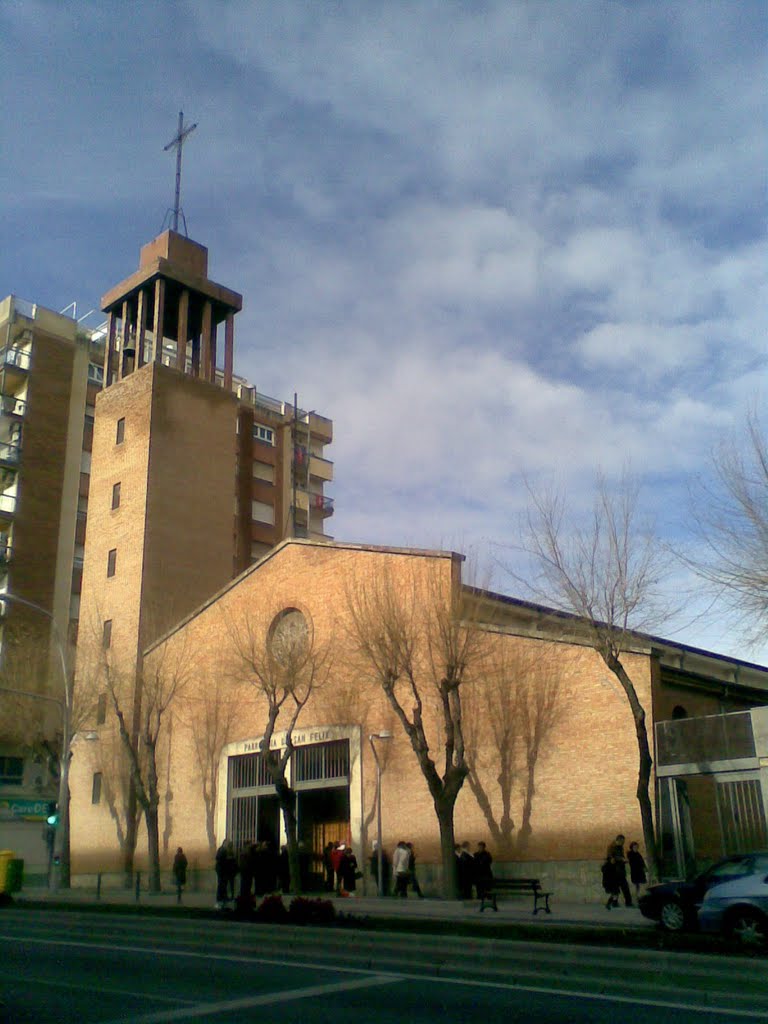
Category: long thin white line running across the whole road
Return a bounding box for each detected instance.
[0,933,765,1024]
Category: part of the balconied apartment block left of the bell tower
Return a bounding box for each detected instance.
[0,295,103,872]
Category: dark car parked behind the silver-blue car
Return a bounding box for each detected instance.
[638,851,768,932]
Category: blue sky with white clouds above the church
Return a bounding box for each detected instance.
[0,0,768,664]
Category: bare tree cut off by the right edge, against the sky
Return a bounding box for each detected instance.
[686,413,768,642]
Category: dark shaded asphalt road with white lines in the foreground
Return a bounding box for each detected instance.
[0,908,768,1024]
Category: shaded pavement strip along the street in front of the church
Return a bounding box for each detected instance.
[14,887,656,931]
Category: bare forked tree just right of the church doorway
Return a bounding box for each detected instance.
[347,556,483,899]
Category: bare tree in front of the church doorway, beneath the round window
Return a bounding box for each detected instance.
[227,608,331,893]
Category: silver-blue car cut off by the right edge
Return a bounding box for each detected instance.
[698,853,768,948]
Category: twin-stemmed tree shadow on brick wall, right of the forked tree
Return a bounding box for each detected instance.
[465,641,564,856]
